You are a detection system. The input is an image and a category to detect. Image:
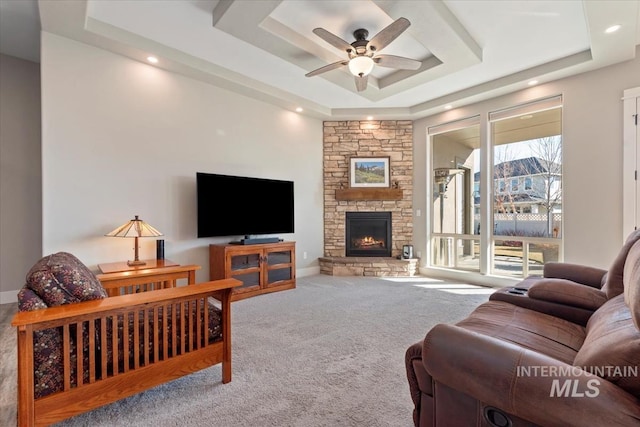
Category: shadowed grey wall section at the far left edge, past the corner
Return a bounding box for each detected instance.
[0,55,42,304]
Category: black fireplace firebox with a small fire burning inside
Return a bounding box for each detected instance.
[345,212,391,257]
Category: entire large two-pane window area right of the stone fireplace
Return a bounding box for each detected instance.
[427,96,562,277]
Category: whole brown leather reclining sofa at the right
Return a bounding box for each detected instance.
[406,231,640,427]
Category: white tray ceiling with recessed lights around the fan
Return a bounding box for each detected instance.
[0,0,640,119]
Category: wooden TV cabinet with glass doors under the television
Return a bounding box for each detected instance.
[209,242,296,301]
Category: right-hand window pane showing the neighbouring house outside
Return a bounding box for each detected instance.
[489,99,562,277]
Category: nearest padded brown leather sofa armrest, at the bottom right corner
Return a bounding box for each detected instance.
[423,325,640,426]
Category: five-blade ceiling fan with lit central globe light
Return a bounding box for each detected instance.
[305,18,422,92]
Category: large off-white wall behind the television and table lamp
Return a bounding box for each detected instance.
[42,33,323,281]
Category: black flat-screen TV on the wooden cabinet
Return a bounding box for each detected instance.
[196,172,294,237]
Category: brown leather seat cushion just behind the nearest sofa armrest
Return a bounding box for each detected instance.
[456,301,585,364]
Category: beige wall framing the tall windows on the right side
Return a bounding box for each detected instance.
[413,48,640,276]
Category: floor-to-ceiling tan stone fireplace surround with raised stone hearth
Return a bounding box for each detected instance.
[320,120,417,276]
